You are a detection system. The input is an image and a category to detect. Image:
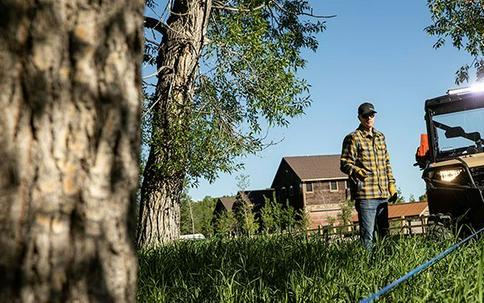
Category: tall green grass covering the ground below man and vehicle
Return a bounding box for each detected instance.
[138,235,484,302]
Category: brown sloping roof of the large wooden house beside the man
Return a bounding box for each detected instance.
[283,155,348,181]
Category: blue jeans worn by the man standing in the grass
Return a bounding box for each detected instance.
[355,199,389,250]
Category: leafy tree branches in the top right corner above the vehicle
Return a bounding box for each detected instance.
[425,0,484,84]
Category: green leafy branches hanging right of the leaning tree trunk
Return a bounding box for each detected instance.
[145,0,334,182]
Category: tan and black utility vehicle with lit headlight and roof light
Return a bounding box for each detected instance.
[416,83,484,229]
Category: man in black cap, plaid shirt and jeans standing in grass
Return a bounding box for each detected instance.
[340,103,397,250]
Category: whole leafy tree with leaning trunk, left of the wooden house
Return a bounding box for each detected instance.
[137,0,329,246]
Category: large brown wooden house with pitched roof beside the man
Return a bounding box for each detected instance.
[271,155,350,227]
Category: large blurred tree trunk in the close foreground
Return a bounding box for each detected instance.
[0,0,143,302]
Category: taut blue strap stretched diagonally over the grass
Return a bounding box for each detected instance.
[359,227,484,303]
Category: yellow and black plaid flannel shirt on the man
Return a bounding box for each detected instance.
[340,124,395,200]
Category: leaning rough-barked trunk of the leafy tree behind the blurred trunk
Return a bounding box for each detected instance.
[137,0,211,247]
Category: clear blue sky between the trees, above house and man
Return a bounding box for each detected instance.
[146,0,471,200]
